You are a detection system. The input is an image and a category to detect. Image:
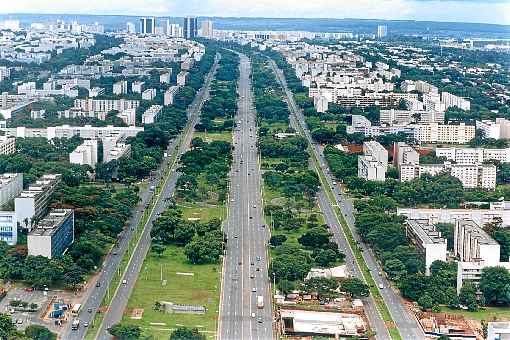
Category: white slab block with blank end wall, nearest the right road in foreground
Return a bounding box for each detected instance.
[405,219,446,275]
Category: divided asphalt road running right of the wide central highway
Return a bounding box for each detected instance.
[271,62,424,340]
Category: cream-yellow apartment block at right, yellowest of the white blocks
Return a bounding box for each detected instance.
[414,123,475,144]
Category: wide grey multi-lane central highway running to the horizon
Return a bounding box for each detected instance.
[218,55,273,340]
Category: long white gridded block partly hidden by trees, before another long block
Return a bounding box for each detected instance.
[400,162,496,190]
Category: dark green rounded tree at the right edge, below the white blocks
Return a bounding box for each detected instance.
[480,267,510,305]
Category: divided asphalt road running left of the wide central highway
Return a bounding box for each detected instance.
[62,56,219,340]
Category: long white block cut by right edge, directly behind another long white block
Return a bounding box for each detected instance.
[436,148,510,165]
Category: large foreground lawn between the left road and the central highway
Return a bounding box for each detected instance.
[123,246,221,339]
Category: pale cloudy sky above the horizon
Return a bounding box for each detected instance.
[0,0,510,25]
